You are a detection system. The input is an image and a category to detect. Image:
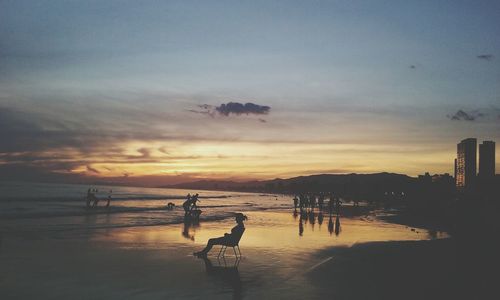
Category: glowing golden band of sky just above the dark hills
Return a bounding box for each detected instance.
[66,141,454,180]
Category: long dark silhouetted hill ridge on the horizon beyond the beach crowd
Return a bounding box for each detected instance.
[164,172,417,198]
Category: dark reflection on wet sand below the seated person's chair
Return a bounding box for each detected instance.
[202,256,243,299]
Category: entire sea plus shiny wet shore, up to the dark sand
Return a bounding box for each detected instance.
[0,182,446,299]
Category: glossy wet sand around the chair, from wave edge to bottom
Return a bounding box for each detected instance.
[0,211,450,299]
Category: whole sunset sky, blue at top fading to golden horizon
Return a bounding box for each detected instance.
[0,0,500,185]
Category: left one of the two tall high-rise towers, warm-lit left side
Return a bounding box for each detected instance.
[455,138,477,188]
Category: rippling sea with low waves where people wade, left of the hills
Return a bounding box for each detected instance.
[0,182,291,231]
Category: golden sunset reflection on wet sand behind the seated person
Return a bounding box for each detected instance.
[95,211,446,255]
